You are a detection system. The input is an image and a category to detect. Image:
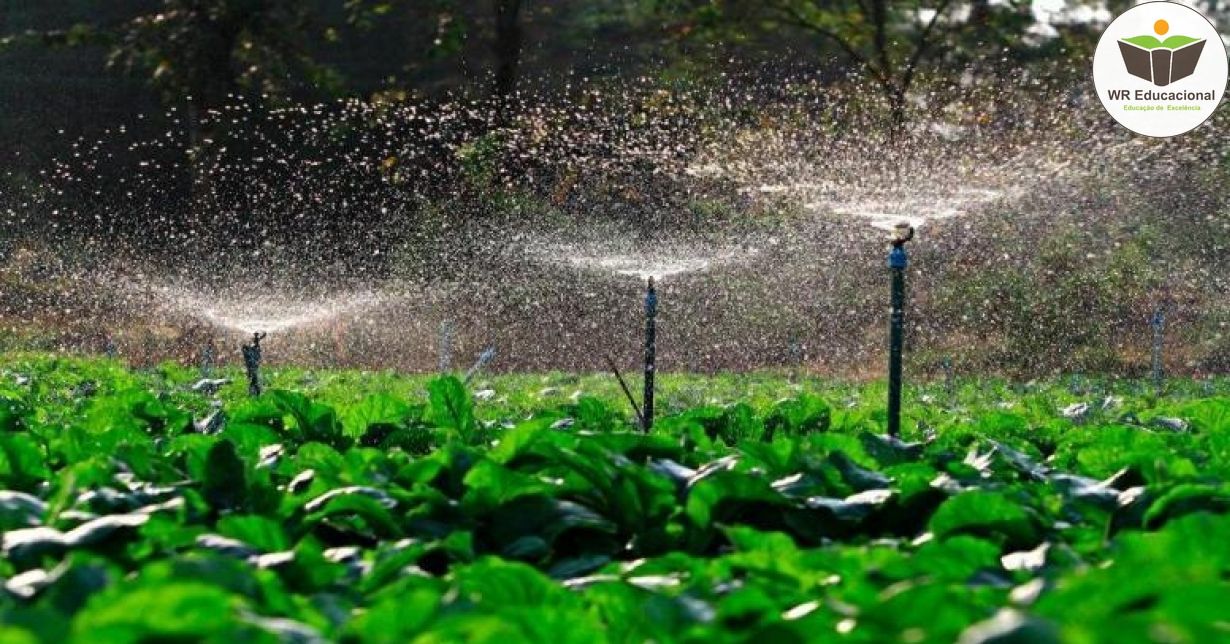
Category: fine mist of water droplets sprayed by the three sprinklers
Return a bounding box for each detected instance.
[0,75,1225,370]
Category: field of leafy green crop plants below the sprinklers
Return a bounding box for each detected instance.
[0,355,1230,644]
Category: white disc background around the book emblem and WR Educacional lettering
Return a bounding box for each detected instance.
[1093,2,1228,136]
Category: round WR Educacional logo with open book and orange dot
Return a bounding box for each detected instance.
[1093,2,1228,136]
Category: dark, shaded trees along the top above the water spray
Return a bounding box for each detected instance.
[0,0,1126,187]
